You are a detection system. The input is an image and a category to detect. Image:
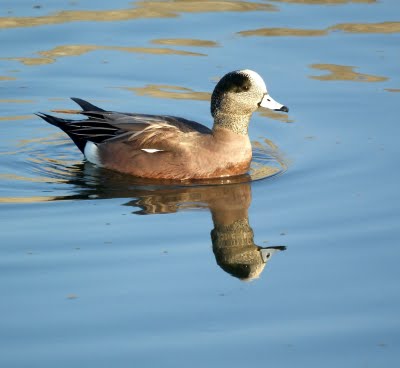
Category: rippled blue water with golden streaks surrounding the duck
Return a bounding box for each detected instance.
[0,0,400,367]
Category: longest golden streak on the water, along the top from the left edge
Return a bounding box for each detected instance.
[0,0,276,29]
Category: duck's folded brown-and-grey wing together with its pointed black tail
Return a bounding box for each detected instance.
[37,98,211,152]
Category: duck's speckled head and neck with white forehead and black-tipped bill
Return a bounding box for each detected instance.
[211,69,289,134]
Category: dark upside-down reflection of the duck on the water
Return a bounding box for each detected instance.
[68,164,286,281]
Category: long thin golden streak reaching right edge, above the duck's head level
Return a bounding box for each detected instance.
[237,22,400,37]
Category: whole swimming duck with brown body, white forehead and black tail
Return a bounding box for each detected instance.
[37,70,289,180]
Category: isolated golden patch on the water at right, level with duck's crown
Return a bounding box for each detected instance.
[310,64,388,82]
